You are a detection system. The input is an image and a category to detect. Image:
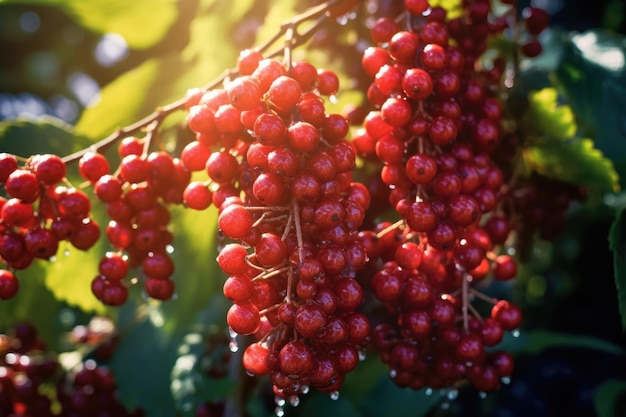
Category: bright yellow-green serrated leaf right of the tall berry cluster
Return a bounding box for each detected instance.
[523,88,619,192]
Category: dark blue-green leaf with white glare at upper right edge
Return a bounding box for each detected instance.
[556,30,626,183]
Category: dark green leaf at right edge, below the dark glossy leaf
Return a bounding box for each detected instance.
[609,209,626,332]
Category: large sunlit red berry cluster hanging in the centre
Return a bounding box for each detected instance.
[181,51,370,399]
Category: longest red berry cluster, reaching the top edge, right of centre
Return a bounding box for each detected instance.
[355,0,536,391]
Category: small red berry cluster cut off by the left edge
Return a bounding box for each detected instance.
[0,153,100,299]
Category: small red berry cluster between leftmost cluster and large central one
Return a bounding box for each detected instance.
[78,137,191,306]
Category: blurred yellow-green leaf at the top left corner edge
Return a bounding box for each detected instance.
[0,0,178,49]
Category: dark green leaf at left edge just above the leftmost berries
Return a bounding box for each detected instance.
[0,116,90,158]
